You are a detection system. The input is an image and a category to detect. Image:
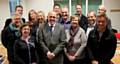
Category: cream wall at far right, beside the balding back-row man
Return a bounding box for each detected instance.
[103,0,120,32]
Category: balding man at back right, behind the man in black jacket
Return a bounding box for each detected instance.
[98,5,112,29]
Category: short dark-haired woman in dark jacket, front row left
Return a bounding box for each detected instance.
[14,24,37,64]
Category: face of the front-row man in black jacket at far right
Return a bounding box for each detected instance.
[97,17,107,30]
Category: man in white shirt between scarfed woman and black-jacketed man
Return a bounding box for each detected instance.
[86,11,96,37]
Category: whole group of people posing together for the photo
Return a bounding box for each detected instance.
[1,4,117,64]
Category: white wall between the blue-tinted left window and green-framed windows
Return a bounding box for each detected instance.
[21,0,54,20]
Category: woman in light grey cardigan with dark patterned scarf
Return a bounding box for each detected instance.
[64,16,87,64]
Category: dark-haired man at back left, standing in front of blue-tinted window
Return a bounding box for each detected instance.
[4,5,25,28]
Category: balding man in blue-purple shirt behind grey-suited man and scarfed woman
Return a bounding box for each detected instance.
[60,7,71,29]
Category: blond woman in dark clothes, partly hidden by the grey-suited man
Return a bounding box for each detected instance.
[31,11,45,63]
